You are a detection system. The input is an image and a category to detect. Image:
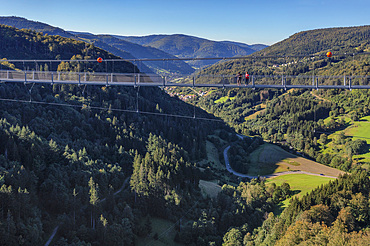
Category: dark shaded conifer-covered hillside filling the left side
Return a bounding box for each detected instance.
[0,25,222,245]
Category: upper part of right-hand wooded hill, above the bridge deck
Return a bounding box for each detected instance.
[198,26,370,75]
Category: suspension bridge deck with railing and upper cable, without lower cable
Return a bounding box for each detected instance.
[0,53,370,90]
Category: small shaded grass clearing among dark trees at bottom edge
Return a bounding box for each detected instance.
[135,218,182,246]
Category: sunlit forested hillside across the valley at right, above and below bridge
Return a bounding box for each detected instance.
[184,26,370,171]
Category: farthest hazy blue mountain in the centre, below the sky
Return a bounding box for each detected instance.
[115,34,267,68]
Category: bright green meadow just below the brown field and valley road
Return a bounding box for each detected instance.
[267,174,334,211]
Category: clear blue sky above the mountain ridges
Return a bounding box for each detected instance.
[0,0,370,45]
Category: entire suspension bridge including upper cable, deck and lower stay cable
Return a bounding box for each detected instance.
[0,52,370,121]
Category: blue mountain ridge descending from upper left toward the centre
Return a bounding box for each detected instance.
[0,16,194,74]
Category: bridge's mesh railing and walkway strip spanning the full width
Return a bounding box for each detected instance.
[0,70,370,89]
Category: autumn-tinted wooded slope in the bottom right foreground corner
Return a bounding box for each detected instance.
[236,173,370,246]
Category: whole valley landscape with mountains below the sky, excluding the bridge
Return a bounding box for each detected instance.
[0,18,370,246]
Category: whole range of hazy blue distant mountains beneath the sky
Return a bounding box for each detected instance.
[0,16,267,71]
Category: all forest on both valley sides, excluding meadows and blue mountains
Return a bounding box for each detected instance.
[0,21,370,245]
